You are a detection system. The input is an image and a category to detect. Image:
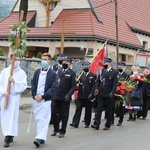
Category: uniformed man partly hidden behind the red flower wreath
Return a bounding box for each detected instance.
[112,62,129,126]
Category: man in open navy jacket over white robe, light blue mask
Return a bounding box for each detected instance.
[31,53,57,147]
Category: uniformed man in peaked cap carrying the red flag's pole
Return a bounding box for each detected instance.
[70,62,96,128]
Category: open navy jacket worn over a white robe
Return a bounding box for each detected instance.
[31,68,57,101]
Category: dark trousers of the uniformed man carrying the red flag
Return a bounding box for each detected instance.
[72,99,92,126]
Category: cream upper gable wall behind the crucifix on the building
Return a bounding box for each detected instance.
[14,0,90,27]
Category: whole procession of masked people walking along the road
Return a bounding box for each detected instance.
[0,53,150,147]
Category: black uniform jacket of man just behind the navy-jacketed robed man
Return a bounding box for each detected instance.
[53,68,76,100]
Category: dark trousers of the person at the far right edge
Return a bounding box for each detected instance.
[137,97,150,118]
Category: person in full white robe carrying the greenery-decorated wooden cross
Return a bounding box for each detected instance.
[0,55,27,147]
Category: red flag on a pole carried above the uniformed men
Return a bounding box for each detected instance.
[90,44,108,75]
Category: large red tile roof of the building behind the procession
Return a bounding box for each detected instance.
[0,0,150,47]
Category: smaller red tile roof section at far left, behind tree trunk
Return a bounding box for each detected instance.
[0,11,36,37]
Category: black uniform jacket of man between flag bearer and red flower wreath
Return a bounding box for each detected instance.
[96,68,118,97]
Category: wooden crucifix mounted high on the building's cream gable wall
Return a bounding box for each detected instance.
[39,0,60,27]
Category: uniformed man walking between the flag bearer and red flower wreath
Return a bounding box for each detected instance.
[91,58,118,130]
